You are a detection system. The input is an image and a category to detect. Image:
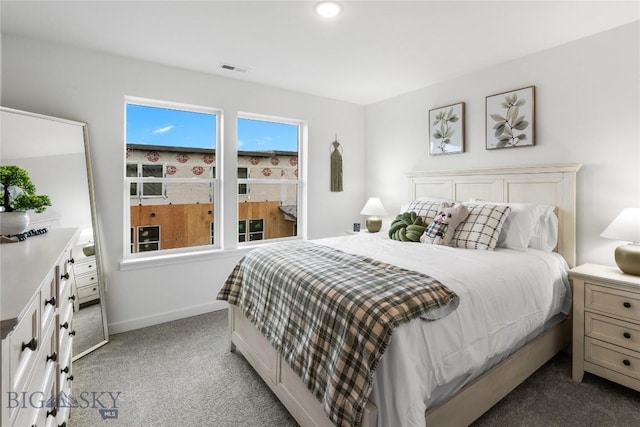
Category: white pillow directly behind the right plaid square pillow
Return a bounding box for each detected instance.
[470,199,553,250]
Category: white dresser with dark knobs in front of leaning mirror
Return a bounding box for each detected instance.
[0,228,77,427]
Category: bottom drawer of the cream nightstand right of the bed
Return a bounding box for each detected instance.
[584,338,640,380]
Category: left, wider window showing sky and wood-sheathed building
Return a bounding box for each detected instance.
[125,98,220,256]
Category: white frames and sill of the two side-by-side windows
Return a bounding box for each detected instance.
[120,100,308,271]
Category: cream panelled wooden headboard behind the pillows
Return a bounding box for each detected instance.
[407,163,582,267]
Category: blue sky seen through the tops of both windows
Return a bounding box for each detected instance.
[126,104,298,151]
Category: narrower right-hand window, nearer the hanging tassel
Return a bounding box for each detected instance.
[237,115,302,243]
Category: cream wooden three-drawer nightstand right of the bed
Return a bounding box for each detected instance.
[569,264,640,391]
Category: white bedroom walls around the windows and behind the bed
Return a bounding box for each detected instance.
[1,22,640,332]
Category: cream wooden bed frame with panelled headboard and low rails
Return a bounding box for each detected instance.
[229,164,581,427]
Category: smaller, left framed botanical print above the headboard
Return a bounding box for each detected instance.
[429,102,464,156]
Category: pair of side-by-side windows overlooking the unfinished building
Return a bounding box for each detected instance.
[123,97,306,265]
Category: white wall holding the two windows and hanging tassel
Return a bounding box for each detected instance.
[2,35,365,332]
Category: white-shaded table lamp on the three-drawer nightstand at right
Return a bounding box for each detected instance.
[600,208,640,276]
